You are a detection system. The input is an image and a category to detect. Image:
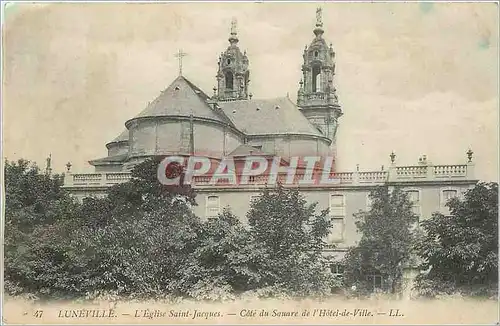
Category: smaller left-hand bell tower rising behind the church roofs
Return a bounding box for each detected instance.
[216,19,250,101]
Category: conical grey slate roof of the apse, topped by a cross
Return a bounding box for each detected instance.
[129,76,230,123]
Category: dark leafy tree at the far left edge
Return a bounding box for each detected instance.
[4,159,79,296]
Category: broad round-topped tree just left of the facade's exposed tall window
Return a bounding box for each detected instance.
[247,185,334,296]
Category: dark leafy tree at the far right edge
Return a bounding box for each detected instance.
[416,183,498,295]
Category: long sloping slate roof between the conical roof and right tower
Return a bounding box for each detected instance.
[217,97,324,137]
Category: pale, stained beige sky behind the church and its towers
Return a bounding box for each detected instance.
[2,3,499,180]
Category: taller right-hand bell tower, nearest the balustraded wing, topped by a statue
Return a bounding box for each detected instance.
[297,8,342,148]
